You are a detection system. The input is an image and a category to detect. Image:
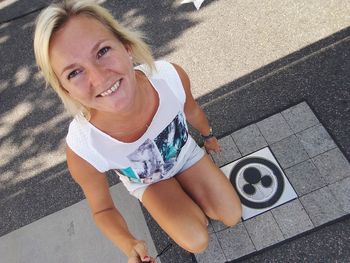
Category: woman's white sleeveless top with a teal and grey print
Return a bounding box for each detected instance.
[66,61,195,193]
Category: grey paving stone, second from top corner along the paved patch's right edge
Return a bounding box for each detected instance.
[296,124,336,157]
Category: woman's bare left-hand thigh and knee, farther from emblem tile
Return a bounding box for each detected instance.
[142,178,208,253]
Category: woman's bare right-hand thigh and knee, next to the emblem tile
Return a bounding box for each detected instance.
[175,154,241,225]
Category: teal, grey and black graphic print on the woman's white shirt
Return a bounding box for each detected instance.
[117,113,188,183]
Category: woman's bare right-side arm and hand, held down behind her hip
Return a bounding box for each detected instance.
[173,64,220,152]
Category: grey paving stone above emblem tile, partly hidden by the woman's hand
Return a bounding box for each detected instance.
[211,135,241,167]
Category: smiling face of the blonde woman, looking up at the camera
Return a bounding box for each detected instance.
[49,15,137,114]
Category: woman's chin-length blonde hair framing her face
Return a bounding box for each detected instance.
[34,0,155,119]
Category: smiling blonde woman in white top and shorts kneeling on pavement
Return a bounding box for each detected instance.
[34,0,241,263]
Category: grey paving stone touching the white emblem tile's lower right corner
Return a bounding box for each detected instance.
[271,199,314,238]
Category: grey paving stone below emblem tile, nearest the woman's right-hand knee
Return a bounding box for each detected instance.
[244,211,284,250]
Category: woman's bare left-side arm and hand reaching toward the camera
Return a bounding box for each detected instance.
[66,146,151,262]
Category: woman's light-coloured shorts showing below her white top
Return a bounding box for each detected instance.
[131,143,205,202]
